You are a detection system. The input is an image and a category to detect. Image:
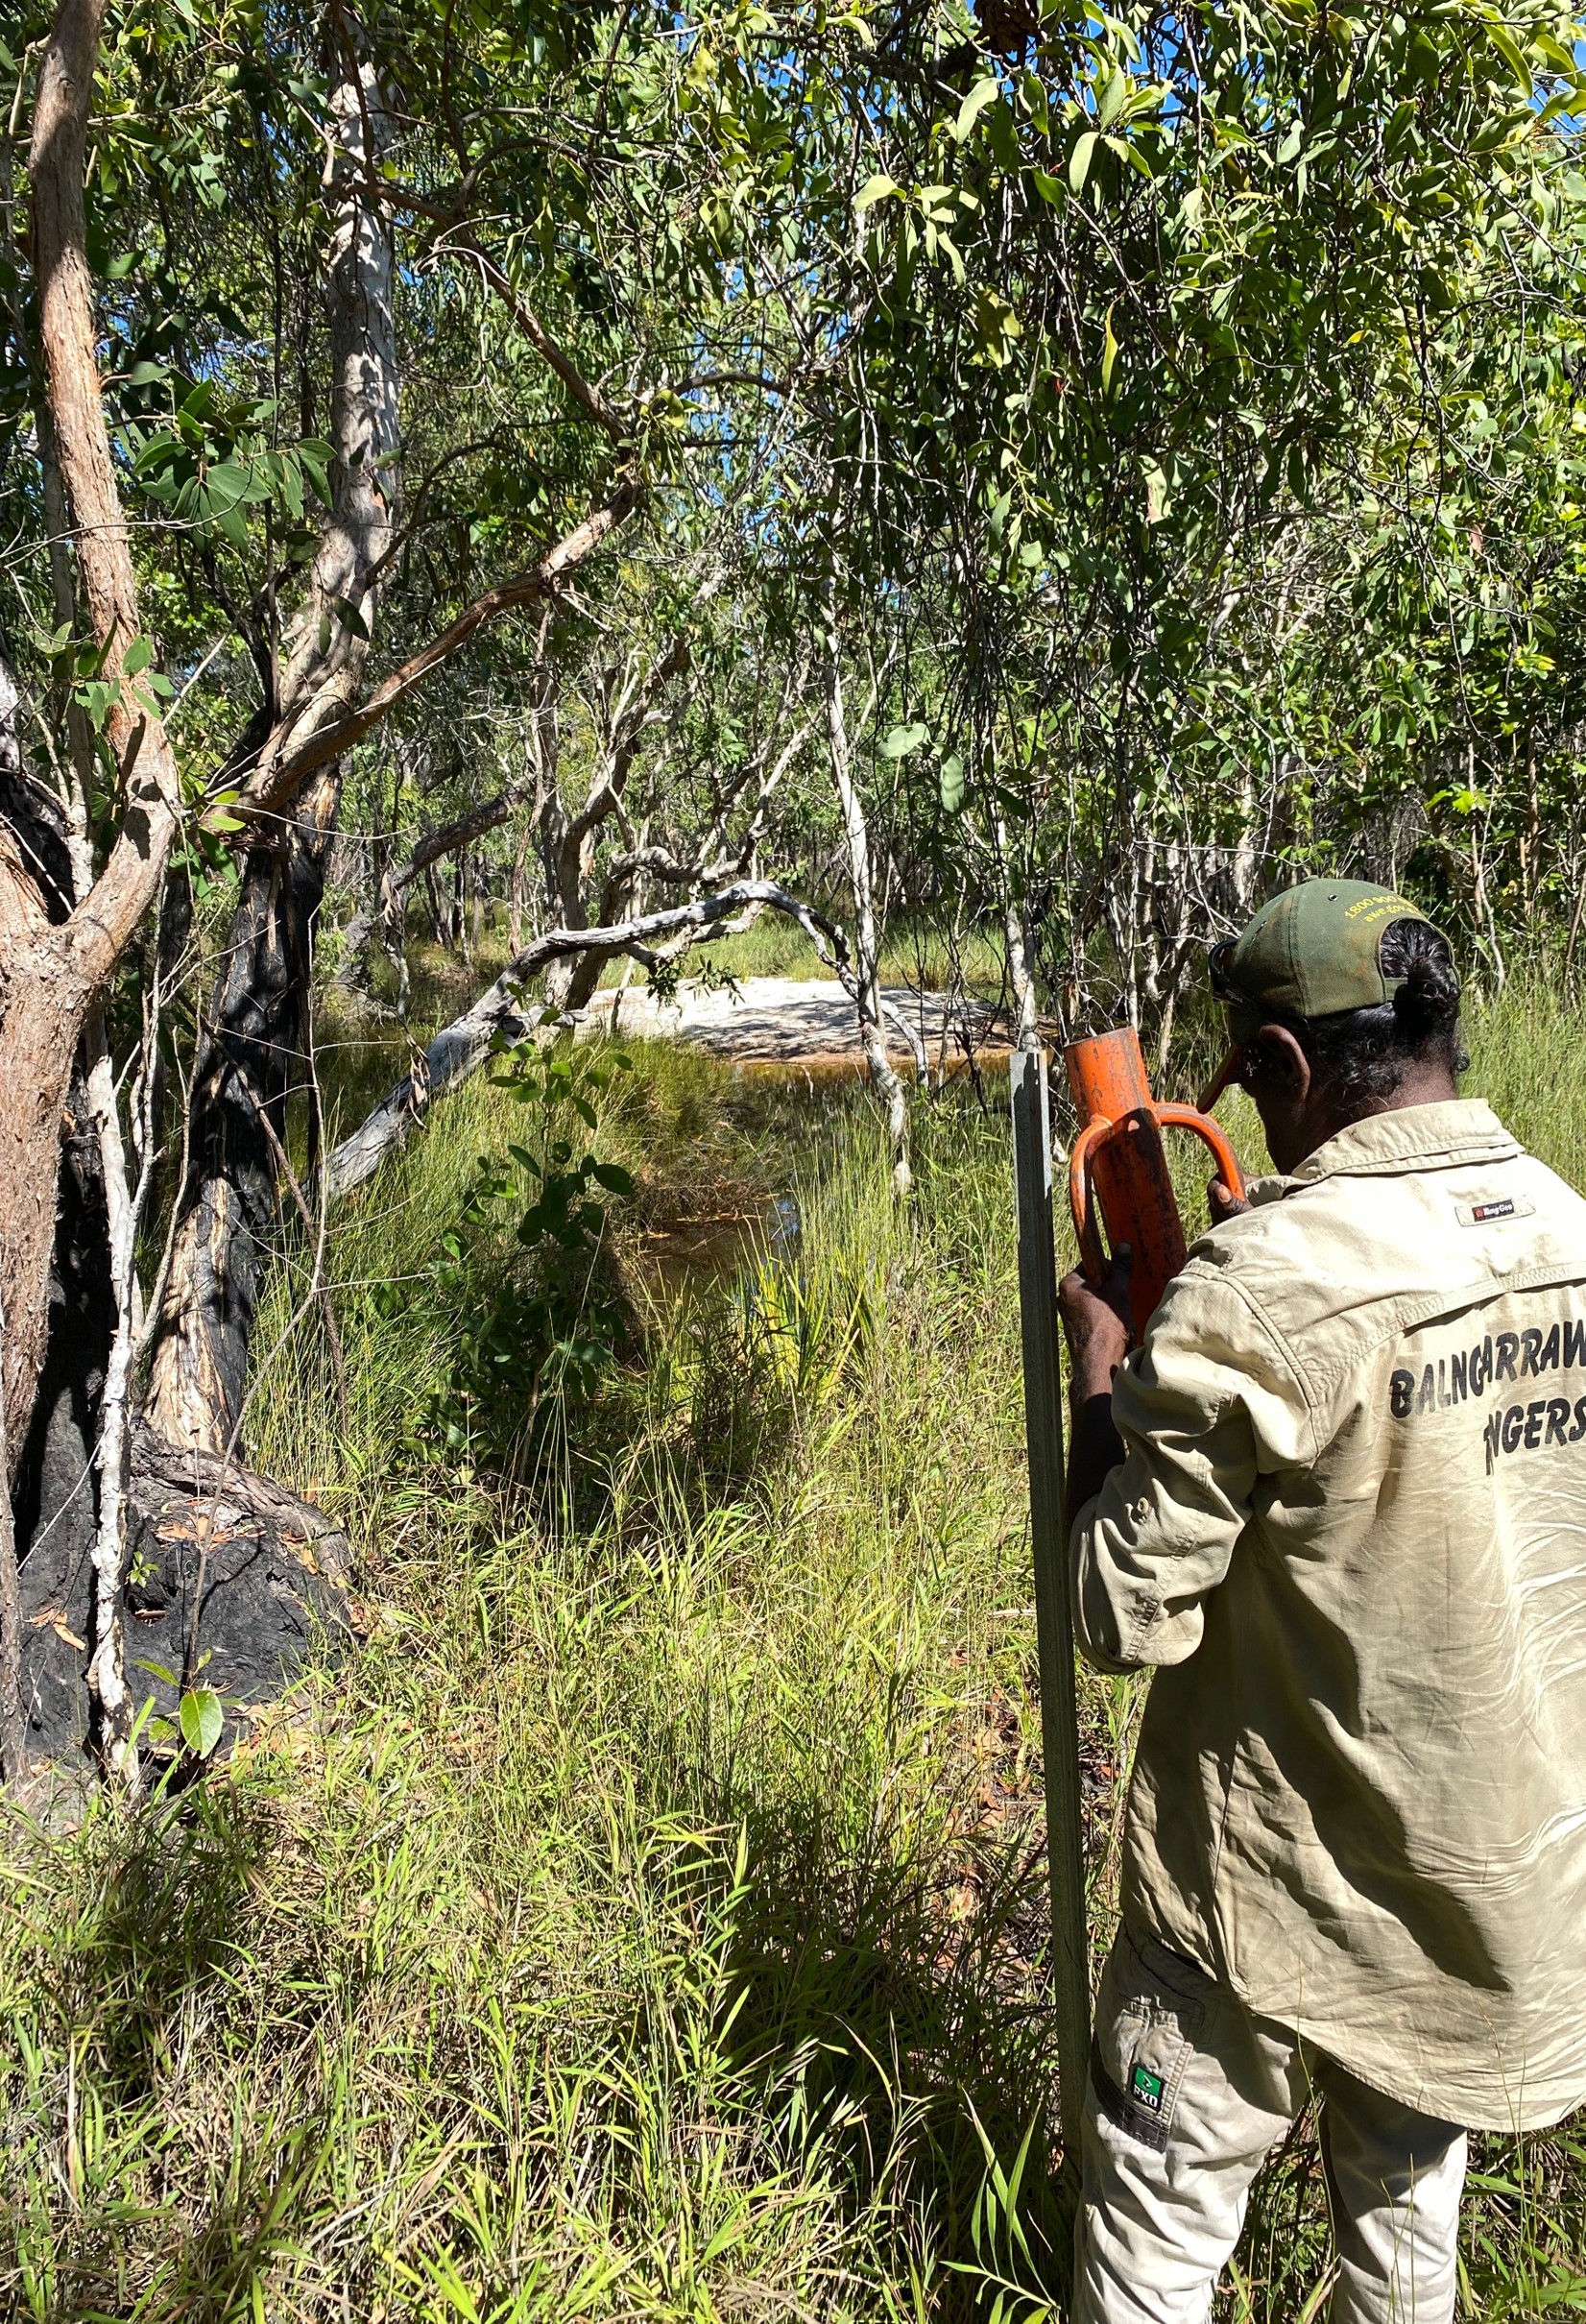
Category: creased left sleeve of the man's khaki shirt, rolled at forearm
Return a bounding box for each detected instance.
[1069,1273,1319,1671]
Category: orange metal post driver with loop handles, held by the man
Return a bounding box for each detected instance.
[1064,1025,1244,1345]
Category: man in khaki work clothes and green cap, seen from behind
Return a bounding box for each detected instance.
[1061,881,1586,2324]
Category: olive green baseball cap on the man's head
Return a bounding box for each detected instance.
[1213,879,1426,1018]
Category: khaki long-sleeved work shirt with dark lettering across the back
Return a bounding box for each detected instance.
[1072,1100,1586,2129]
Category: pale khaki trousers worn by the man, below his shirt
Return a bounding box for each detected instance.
[1072,1929,1465,2324]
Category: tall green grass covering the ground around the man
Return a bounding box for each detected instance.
[0,985,1586,2324]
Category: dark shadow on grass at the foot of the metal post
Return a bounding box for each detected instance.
[727,1810,1069,2319]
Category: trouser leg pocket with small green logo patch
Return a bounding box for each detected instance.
[1092,1929,1216,2154]
